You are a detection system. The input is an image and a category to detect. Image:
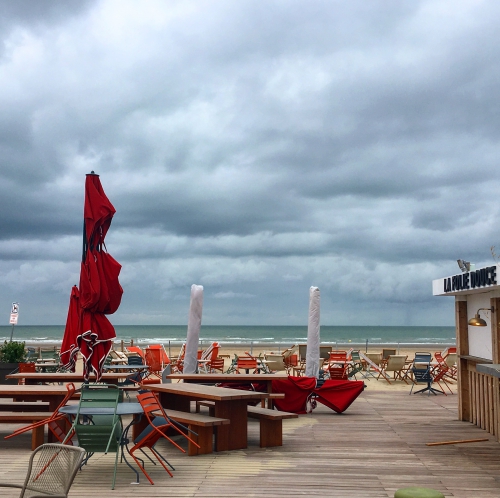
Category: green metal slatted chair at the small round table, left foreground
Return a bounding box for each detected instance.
[63,384,122,489]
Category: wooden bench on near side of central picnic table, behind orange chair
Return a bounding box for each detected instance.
[157,408,229,456]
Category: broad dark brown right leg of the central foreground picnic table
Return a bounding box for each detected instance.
[215,400,248,451]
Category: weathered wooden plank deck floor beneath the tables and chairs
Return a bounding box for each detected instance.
[0,392,500,498]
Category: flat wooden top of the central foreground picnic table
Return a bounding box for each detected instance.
[148,383,268,401]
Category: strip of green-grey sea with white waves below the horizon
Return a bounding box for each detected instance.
[0,325,456,349]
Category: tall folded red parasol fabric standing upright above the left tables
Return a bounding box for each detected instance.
[61,172,123,380]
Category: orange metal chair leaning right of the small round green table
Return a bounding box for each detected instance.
[130,391,200,484]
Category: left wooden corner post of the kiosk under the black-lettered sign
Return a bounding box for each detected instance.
[455,298,472,422]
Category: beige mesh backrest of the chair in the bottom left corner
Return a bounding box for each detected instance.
[20,443,85,498]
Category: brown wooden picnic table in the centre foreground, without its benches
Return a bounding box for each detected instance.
[148,382,268,451]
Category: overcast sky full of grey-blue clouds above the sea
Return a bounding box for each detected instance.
[0,0,500,325]
